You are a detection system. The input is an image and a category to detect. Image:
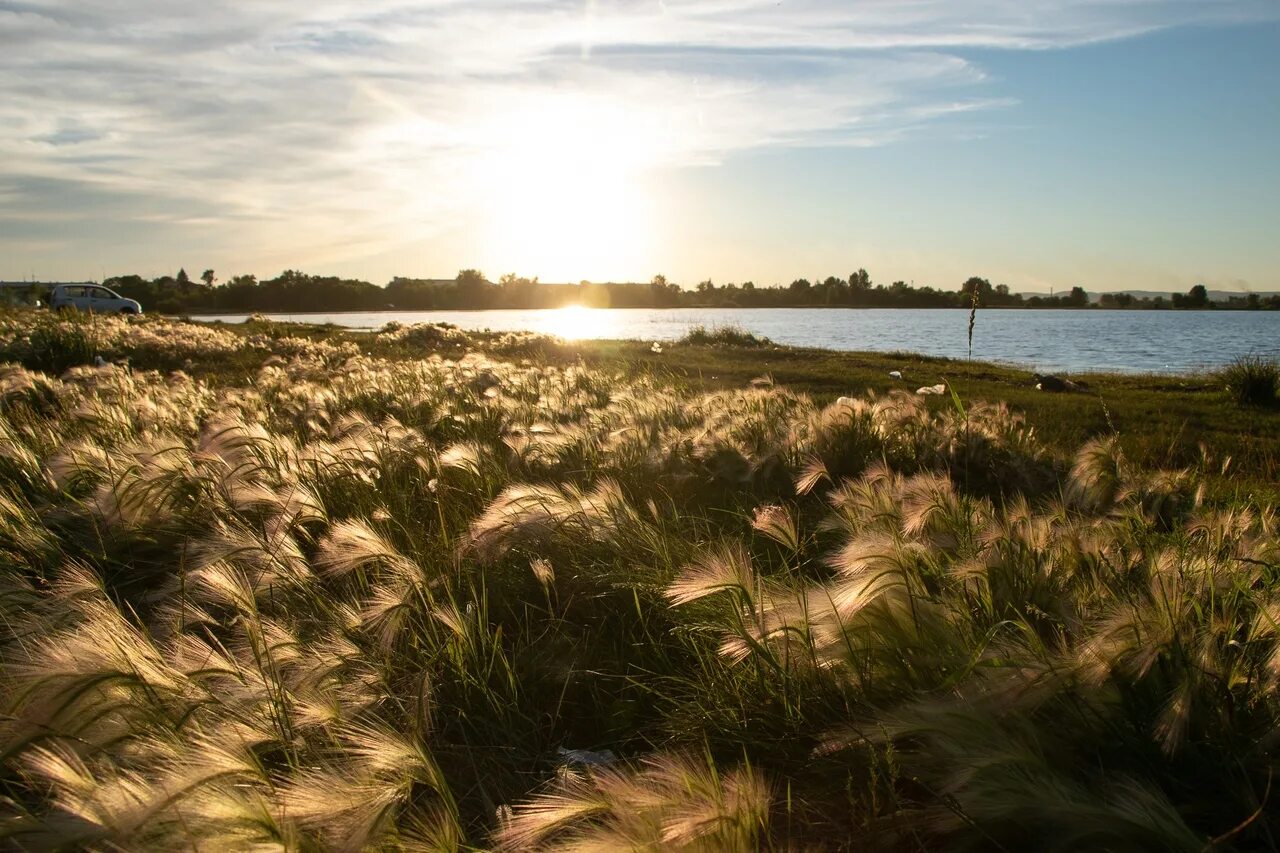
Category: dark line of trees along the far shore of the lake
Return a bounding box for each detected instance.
[104,269,1280,314]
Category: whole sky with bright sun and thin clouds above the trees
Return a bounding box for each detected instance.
[0,0,1280,292]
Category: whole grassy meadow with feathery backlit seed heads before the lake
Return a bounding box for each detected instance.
[0,313,1280,850]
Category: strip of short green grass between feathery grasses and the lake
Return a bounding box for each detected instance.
[227,312,1280,501]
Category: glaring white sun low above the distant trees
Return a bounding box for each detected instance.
[484,96,657,280]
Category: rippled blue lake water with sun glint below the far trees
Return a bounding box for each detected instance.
[189,309,1280,373]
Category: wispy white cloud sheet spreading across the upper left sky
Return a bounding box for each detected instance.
[0,0,1274,268]
